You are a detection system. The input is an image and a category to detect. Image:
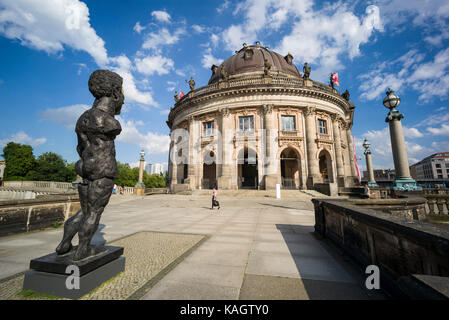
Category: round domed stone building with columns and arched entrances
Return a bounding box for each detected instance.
[167,43,358,193]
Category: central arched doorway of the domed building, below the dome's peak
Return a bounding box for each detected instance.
[237,148,259,189]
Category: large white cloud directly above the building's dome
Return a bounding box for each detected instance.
[221,0,383,81]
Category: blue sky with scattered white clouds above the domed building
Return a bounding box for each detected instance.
[0,0,449,172]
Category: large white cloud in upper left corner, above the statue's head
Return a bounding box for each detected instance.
[0,0,108,66]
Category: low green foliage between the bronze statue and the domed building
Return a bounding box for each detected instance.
[115,162,166,188]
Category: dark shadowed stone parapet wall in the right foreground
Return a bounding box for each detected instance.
[312,199,449,298]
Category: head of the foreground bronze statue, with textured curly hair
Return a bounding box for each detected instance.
[89,70,125,115]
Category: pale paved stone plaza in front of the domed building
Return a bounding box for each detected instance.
[0,190,386,300]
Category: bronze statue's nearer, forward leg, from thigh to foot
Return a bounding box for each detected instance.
[73,178,114,260]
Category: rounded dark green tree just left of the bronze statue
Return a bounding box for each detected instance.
[26,152,76,182]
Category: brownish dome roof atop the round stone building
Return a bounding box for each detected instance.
[209,45,301,84]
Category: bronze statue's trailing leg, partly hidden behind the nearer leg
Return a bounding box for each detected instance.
[56,183,88,254]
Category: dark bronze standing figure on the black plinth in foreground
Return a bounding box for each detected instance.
[56,70,125,261]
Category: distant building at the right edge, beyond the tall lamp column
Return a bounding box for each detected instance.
[410,152,449,180]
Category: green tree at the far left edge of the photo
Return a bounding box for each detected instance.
[2,142,36,180]
